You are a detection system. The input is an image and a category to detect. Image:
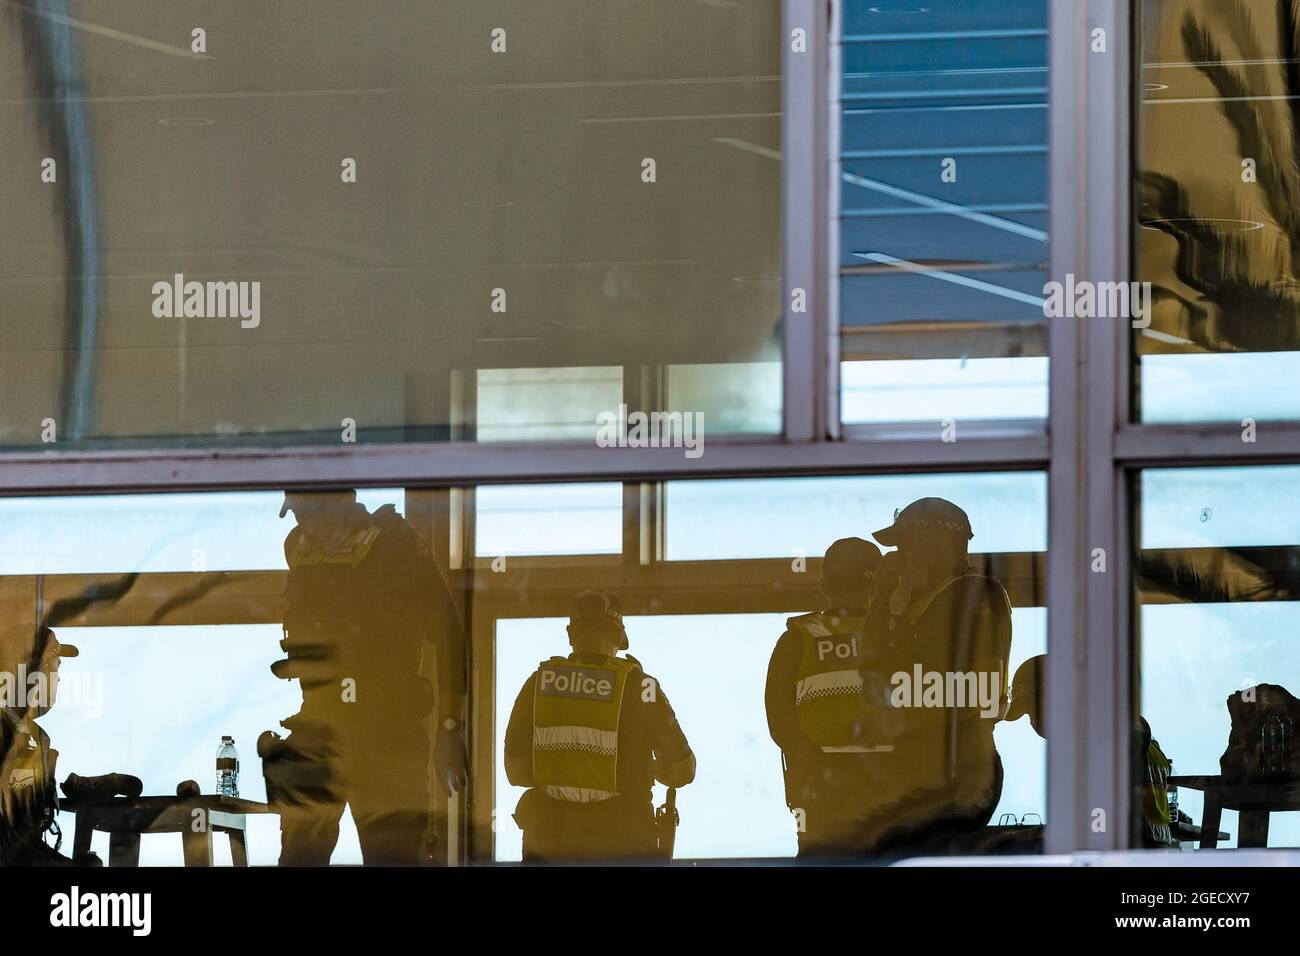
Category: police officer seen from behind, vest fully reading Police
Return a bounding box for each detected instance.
[506,591,696,862]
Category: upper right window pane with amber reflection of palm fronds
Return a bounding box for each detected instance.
[1134,0,1300,423]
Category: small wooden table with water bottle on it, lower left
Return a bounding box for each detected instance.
[59,793,273,866]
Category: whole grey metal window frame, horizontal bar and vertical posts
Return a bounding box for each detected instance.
[12,0,1300,857]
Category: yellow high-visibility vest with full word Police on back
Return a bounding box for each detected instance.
[533,657,640,804]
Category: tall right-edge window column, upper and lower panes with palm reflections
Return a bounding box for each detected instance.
[1121,0,1300,848]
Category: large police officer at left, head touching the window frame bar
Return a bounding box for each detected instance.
[257,490,467,865]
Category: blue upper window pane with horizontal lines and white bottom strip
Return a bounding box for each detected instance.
[840,0,1048,424]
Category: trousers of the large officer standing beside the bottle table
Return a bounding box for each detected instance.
[280,726,430,866]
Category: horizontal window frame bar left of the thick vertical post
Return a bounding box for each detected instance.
[0,428,1048,496]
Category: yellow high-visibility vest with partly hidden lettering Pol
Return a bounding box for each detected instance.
[788,613,863,753]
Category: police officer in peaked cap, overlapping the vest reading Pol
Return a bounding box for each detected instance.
[862,498,1011,855]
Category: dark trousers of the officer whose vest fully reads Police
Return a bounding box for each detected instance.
[516,791,663,864]
